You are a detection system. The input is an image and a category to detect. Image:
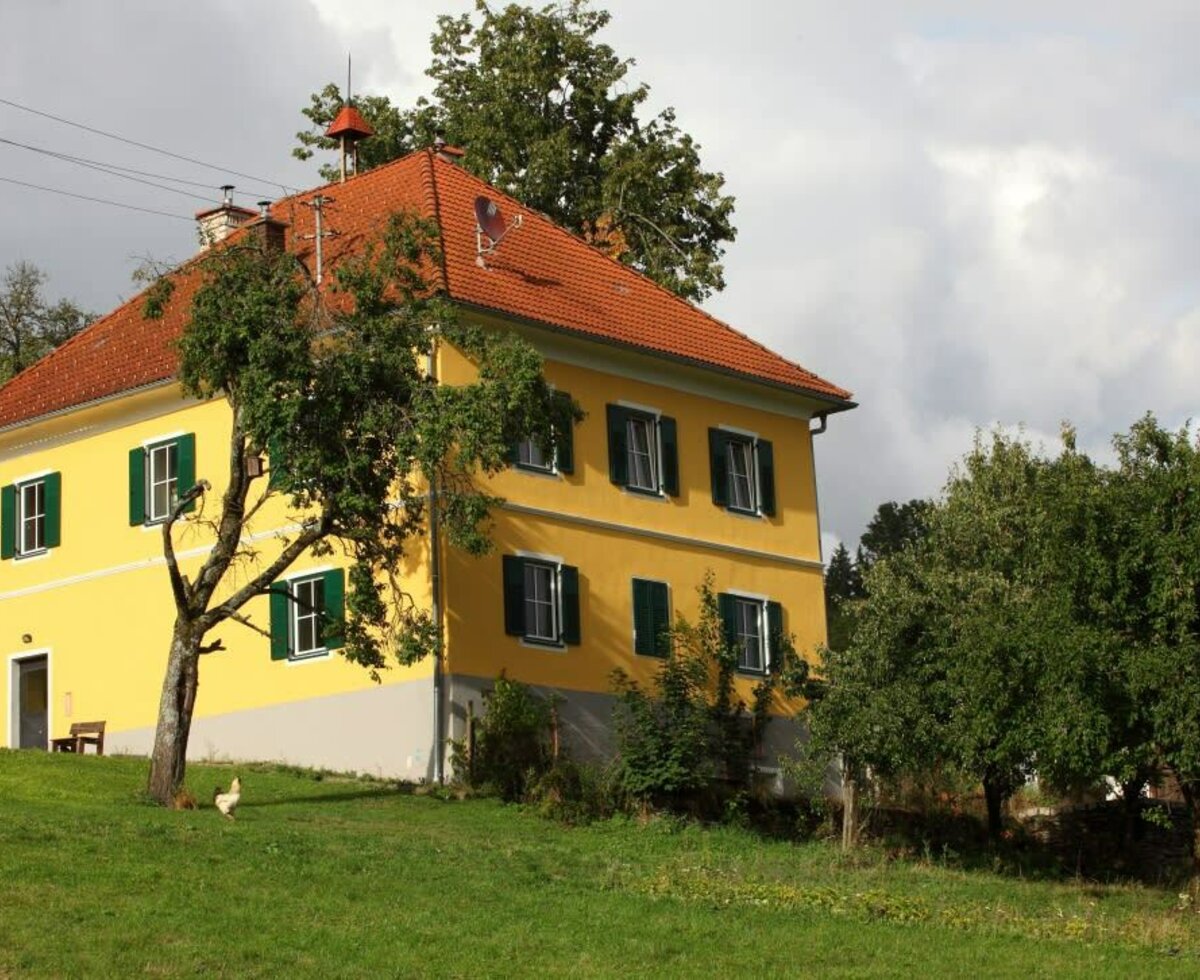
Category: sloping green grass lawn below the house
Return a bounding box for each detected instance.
[0,750,1200,978]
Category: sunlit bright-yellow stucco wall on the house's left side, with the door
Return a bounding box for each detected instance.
[0,386,431,745]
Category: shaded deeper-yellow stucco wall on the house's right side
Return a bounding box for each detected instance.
[439,333,826,697]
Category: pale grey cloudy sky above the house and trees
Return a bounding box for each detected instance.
[0,0,1200,547]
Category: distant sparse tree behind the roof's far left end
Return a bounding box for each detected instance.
[0,261,96,384]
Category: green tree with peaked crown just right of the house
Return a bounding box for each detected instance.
[810,433,1067,840]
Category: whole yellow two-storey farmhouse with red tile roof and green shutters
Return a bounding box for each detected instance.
[0,139,853,778]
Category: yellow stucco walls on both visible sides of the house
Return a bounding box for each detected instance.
[0,314,826,745]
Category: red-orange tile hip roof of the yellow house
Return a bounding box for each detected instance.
[0,150,851,427]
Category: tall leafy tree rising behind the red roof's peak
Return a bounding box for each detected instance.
[293,0,736,300]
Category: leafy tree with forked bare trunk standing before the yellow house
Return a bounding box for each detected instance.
[140,214,577,802]
